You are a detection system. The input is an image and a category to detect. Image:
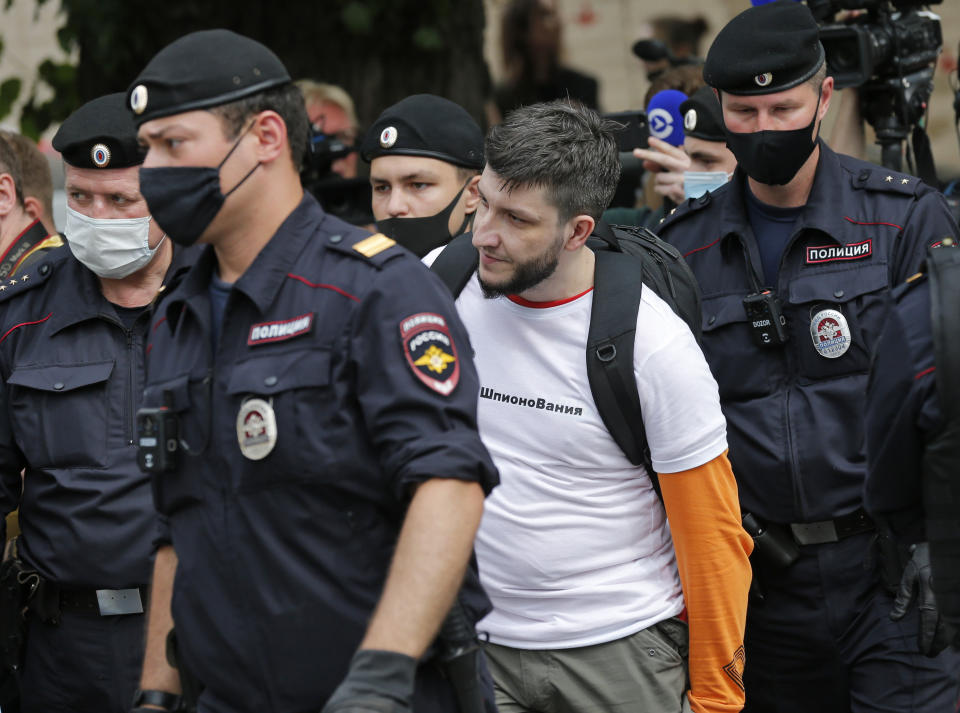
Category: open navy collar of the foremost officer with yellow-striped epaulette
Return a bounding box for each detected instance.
[164,191,325,324]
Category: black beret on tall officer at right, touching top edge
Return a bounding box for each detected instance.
[703,0,824,95]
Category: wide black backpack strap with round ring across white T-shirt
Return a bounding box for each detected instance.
[587,250,660,495]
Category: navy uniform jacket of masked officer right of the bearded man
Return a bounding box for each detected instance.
[661,141,956,523]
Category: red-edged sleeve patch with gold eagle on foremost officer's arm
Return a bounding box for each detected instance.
[400,312,460,396]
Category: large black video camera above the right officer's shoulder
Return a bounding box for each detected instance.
[807,0,943,170]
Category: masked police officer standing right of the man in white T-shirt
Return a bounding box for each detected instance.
[660,0,957,712]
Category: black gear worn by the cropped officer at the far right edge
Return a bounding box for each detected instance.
[922,246,960,645]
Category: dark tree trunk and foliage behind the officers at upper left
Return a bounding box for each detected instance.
[0,0,490,138]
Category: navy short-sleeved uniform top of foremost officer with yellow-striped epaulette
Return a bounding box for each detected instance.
[145,194,497,712]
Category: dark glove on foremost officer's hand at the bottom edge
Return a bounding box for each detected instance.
[321,649,417,713]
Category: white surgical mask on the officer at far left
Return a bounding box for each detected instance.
[64,207,166,280]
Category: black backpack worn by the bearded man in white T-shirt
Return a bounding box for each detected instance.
[431,221,701,494]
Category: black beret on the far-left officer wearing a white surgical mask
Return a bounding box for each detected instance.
[53,92,144,168]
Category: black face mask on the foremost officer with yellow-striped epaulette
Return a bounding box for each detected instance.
[140,124,260,246]
